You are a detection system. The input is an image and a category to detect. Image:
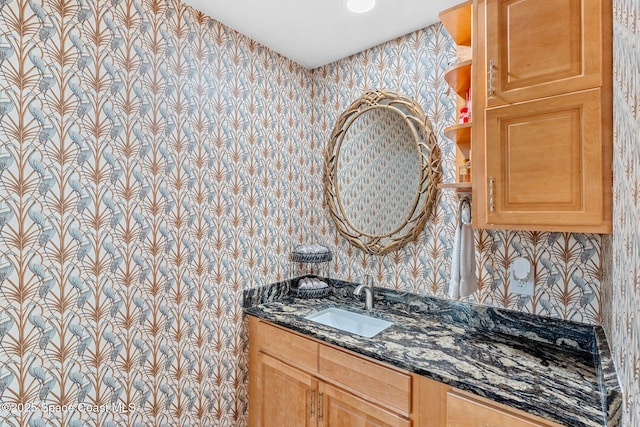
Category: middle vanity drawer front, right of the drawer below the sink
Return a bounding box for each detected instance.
[318,346,411,415]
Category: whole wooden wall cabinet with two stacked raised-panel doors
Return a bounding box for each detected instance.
[472,0,613,233]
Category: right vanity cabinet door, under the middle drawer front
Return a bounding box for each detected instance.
[318,383,411,427]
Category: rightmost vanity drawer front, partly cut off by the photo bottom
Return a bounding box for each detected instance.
[446,391,561,427]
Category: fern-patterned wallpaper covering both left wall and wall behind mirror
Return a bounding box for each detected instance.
[0,0,616,427]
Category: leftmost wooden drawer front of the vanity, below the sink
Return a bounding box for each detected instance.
[249,317,318,373]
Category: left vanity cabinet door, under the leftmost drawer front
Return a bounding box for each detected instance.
[249,353,318,427]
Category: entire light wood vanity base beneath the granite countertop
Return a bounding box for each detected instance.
[249,316,562,427]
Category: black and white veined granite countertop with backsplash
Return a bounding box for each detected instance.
[244,280,621,427]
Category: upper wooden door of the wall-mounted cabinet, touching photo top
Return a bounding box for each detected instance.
[486,0,603,107]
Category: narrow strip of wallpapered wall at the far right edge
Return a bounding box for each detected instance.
[604,0,640,427]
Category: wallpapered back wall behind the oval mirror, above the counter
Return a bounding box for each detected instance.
[312,25,603,323]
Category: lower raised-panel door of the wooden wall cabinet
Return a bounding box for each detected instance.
[485,89,610,232]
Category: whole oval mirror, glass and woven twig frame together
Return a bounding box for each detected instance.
[324,91,440,255]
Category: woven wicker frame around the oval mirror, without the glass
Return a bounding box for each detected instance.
[324,90,440,255]
